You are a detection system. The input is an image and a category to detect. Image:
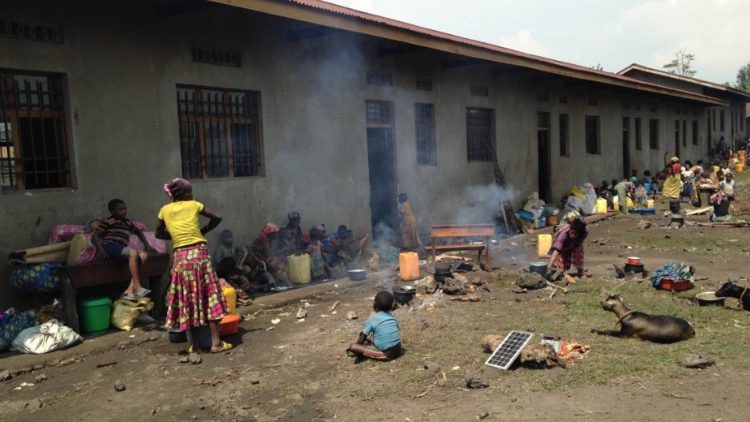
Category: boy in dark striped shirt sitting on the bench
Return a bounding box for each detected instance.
[93,199,156,300]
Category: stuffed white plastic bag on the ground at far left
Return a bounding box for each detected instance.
[10,319,83,355]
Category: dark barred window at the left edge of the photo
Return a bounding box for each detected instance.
[0,69,72,191]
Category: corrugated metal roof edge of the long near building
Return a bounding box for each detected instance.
[209,0,725,105]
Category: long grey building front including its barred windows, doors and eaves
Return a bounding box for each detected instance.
[0,0,740,307]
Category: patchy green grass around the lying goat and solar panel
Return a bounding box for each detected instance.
[382,277,750,399]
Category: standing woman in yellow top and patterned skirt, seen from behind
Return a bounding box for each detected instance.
[156,178,232,353]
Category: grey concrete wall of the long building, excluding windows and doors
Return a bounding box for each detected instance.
[0,1,724,307]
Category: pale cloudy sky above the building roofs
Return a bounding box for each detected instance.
[328,0,750,83]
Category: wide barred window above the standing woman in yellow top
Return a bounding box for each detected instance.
[177,85,263,179]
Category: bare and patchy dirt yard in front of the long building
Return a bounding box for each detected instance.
[0,181,750,421]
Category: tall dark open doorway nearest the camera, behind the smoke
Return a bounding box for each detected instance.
[366,101,398,237]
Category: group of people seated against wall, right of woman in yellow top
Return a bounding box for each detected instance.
[211,211,366,304]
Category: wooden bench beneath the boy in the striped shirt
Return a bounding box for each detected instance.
[60,253,170,332]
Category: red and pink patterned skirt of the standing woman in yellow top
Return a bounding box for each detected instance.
[164,243,228,331]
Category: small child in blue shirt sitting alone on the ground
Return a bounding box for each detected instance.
[346,291,401,361]
